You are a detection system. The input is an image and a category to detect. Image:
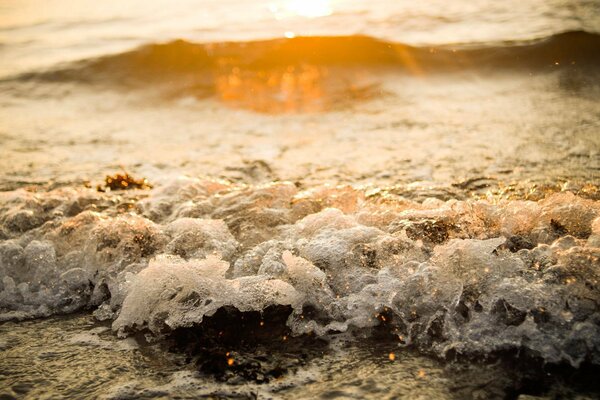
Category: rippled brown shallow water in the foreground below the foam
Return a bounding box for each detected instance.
[0,315,594,399]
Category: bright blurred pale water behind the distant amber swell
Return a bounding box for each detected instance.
[0,0,600,75]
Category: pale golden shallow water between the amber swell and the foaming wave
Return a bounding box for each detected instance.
[0,67,600,190]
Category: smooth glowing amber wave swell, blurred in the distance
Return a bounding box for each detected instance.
[13,31,600,83]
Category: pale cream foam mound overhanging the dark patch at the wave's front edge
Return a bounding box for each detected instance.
[113,256,298,335]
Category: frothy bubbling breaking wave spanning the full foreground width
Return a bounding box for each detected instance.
[0,178,600,366]
